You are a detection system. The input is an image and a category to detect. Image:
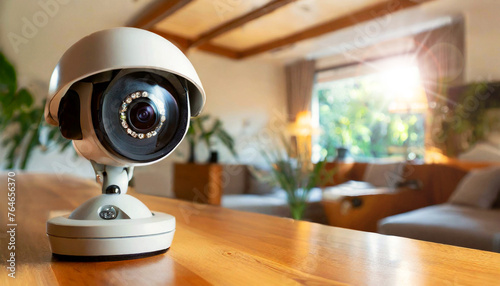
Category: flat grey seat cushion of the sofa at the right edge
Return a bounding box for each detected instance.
[378,204,500,251]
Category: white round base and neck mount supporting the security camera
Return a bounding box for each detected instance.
[47,163,175,261]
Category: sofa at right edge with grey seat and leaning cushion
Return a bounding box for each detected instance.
[378,165,500,252]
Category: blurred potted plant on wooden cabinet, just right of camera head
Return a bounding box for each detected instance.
[186,115,237,163]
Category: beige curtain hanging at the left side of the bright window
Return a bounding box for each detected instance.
[285,60,315,122]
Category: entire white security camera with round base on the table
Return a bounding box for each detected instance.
[45,28,205,259]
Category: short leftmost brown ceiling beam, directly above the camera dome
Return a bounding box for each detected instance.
[129,0,193,29]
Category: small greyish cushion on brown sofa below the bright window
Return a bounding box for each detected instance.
[363,162,405,188]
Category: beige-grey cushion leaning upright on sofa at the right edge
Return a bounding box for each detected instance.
[448,167,500,209]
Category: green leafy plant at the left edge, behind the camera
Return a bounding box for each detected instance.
[0,52,71,170]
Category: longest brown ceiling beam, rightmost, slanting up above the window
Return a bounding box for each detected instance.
[241,0,432,58]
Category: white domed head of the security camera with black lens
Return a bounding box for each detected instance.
[45,28,205,166]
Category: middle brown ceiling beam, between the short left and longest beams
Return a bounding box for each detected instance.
[191,0,297,47]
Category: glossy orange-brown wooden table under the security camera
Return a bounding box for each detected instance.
[0,174,500,285]
